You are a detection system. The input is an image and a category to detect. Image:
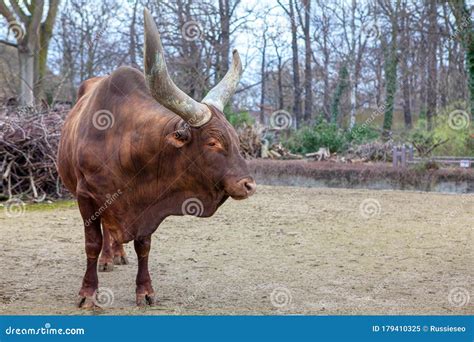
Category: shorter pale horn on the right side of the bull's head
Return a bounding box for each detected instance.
[201,49,242,112]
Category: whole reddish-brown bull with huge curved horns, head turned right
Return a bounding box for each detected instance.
[58,10,256,307]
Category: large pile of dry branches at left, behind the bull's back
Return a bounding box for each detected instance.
[0,107,68,202]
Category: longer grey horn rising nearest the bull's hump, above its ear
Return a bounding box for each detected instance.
[144,9,212,127]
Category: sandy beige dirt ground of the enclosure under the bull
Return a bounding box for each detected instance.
[0,186,474,315]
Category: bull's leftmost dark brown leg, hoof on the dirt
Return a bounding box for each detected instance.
[77,196,102,308]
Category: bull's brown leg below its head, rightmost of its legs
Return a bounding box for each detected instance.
[134,235,155,306]
